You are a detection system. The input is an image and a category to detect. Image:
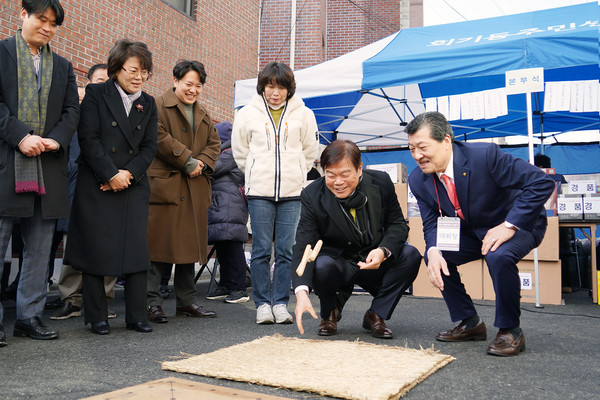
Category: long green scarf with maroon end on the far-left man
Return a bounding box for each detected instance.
[15,29,53,195]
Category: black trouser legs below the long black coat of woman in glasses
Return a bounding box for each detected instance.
[81,271,148,324]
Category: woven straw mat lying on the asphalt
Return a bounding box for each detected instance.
[162,335,454,400]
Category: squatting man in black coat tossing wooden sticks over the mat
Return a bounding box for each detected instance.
[292,140,421,339]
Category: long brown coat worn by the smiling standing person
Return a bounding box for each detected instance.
[148,89,221,264]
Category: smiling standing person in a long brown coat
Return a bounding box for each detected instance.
[148,60,221,323]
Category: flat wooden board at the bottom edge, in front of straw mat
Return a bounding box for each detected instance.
[84,378,288,400]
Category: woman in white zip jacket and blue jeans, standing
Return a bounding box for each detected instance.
[231,62,319,324]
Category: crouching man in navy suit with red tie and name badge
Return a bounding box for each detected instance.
[405,112,554,356]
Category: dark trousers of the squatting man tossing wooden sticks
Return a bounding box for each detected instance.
[313,244,422,320]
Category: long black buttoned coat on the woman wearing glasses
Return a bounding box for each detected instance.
[65,80,157,276]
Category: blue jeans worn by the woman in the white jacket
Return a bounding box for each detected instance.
[248,199,301,307]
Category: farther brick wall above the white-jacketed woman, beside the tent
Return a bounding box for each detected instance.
[260,0,400,69]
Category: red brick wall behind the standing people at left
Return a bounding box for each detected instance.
[0,0,260,121]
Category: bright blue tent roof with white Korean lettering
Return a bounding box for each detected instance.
[362,2,599,89]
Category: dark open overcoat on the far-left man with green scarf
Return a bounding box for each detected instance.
[0,36,79,219]
